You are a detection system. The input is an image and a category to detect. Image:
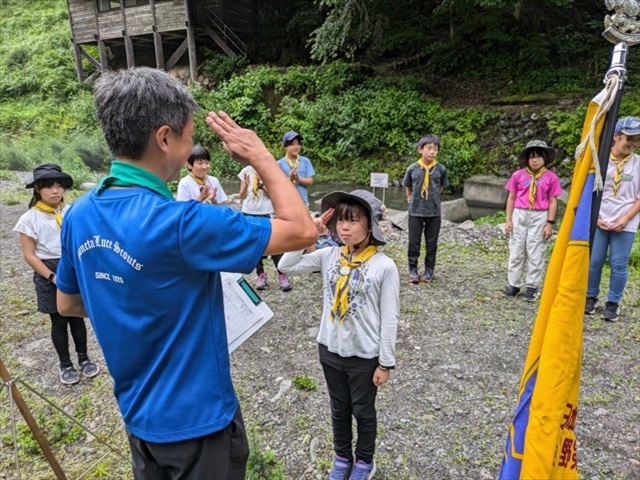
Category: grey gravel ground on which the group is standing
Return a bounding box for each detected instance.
[0,173,640,480]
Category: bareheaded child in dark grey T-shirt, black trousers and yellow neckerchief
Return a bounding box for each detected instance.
[402,135,449,283]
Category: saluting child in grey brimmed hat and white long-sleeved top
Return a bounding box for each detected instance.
[278,190,400,480]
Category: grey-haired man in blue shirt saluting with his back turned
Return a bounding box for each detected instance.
[57,68,317,479]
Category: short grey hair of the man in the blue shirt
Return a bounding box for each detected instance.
[94,67,200,160]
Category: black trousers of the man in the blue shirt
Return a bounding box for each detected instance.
[127,407,249,480]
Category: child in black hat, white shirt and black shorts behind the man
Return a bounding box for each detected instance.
[13,163,100,385]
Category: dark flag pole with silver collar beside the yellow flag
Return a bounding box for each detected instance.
[589,42,629,245]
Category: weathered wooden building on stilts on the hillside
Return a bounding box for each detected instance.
[67,0,255,82]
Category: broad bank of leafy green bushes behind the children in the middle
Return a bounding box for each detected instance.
[194,62,493,187]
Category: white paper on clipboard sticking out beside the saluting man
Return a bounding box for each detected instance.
[220,272,273,353]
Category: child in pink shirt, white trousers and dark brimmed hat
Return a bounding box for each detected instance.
[502,140,562,302]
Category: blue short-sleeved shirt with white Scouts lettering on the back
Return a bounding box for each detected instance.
[57,188,271,443]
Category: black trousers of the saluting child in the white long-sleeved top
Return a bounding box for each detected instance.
[319,344,378,463]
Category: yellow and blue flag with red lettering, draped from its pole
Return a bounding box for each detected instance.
[499,89,608,480]
